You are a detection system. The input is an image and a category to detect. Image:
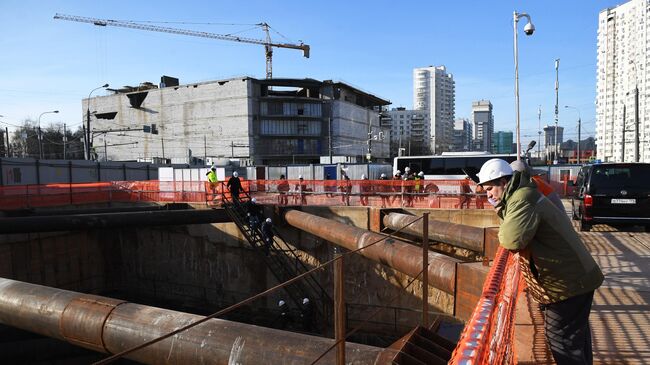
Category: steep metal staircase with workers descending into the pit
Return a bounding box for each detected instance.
[223,193,332,332]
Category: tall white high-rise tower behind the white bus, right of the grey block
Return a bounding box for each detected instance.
[413,66,456,154]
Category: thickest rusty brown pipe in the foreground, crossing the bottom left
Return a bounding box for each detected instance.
[0,278,395,364]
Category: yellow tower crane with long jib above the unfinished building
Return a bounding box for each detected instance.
[54,13,309,79]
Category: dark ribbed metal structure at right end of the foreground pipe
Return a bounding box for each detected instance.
[389,322,456,365]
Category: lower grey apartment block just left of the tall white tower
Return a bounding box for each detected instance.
[382,108,431,156]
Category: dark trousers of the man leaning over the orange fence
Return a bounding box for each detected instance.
[542,291,594,365]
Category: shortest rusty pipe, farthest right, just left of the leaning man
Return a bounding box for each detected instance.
[384,213,485,252]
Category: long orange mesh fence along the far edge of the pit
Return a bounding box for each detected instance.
[0,180,489,210]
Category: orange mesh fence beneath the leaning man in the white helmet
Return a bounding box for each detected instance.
[449,247,524,364]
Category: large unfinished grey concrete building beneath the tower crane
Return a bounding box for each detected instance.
[82,77,390,165]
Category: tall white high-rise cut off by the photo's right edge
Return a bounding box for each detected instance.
[596,0,650,162]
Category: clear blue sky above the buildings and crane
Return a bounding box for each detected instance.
[0,0,620,143]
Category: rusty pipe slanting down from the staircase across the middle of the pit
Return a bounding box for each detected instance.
[284,210,461,294]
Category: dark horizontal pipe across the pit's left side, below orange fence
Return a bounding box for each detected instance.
[0,209,232,233]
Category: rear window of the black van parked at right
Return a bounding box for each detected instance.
[591,165,650,191]
